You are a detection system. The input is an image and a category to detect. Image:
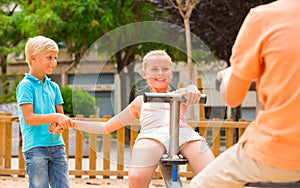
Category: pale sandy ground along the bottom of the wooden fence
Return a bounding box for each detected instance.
[0,176,189,188]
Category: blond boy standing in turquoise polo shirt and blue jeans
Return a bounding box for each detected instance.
[16,36,72,188]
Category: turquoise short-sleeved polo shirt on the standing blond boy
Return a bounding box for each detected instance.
[16,73,64,152]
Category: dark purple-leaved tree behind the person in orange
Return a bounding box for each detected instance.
[146,0,274,120]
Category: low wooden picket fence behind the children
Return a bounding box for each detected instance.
[0,113,249,178]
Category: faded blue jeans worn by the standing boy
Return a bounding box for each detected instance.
[23,145,70,188]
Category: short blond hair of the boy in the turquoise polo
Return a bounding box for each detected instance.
[25,36,59,65]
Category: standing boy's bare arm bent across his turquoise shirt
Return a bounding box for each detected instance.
[21,103,73,128]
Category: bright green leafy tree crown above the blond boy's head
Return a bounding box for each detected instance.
[21,0,106,64]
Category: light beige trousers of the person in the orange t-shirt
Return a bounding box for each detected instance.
[191,144,300,188]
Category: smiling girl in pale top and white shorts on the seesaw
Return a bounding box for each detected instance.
[51,50,214,188]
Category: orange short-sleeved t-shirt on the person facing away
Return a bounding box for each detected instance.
[230,0,300,170]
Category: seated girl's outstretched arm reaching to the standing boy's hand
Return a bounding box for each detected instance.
[74,96,143,134]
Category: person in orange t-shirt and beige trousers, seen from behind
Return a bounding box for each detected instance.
[191,0,300,188]
